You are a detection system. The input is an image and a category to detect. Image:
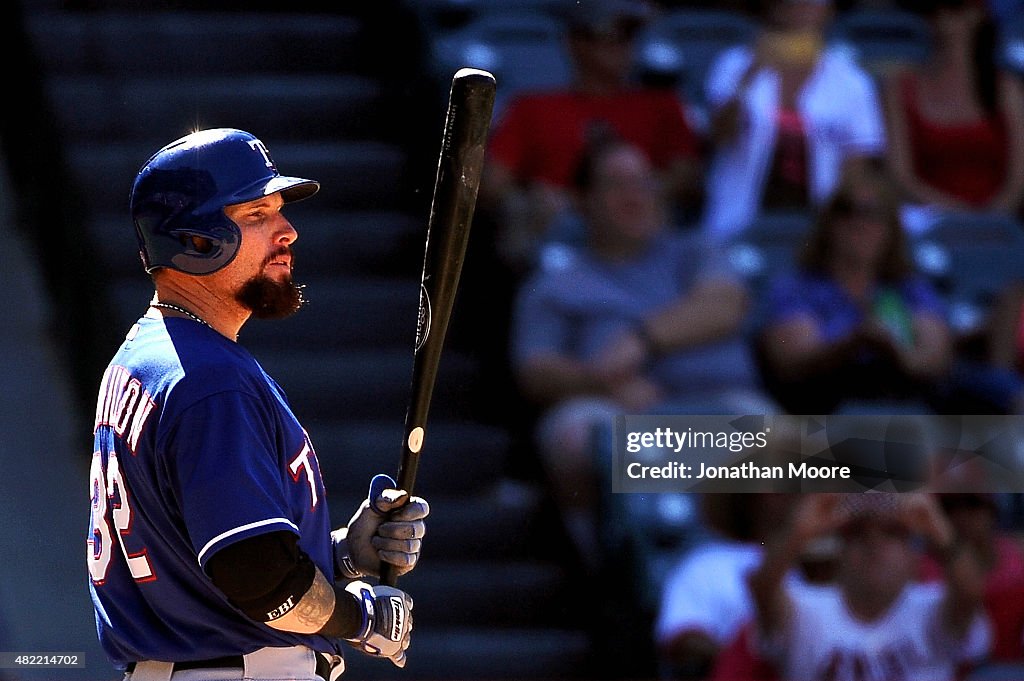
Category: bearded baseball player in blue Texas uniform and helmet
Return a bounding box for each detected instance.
[87,129,428,681]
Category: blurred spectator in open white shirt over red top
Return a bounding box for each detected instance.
[703,0,885,239]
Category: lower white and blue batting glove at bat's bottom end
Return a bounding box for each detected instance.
[345,582,413,667]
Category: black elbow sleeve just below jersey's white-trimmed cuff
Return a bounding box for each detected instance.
[206,531,316,622]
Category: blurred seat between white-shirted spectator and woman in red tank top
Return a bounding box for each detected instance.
[827,8,931,75]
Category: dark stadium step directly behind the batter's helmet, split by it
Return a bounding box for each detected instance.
[67,141,408,214]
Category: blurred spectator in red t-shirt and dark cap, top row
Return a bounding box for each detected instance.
[480,0,703,269]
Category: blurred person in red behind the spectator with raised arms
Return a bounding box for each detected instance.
[922,493,1024,663]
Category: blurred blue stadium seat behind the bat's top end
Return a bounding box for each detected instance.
[432,10,571,114]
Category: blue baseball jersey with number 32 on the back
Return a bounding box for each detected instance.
[87,316,341,668]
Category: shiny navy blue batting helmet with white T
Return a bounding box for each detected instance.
[130,128,319,274]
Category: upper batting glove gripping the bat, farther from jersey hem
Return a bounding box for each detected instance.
[331,475,430,580]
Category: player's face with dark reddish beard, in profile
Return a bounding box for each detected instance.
[224,194,302,318]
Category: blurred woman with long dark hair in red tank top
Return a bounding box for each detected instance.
[884,0,1024,232]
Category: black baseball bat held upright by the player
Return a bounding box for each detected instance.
[380,69,496,586]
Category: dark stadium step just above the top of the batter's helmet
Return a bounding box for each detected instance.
[39,74,397,142]
